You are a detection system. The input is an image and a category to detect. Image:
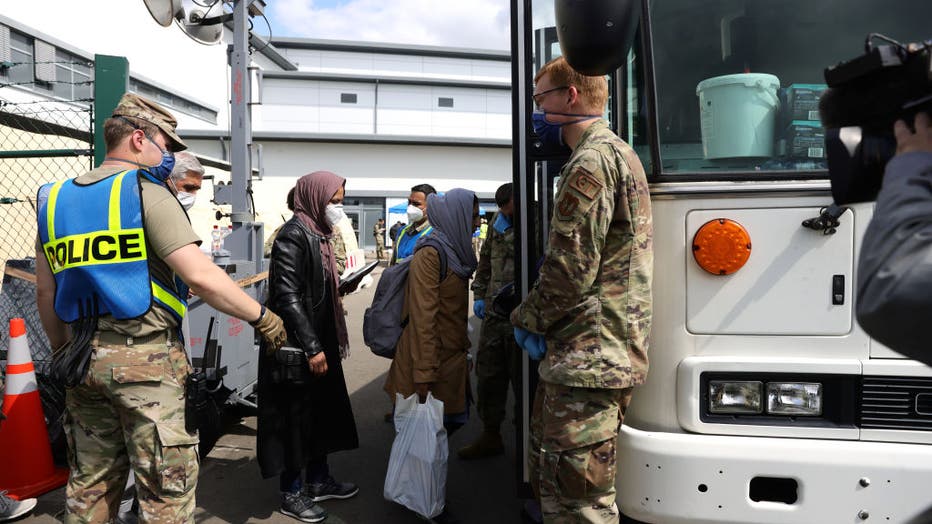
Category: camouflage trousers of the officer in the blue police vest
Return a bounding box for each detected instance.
[65,334,199,524]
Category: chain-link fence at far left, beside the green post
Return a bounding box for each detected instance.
[0,64,94,386]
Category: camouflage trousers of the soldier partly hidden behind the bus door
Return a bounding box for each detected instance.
[476,312,521,430]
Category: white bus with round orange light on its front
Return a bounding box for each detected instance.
[511,0,932,524]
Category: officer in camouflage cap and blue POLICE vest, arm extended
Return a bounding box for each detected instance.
[36,94,285,523]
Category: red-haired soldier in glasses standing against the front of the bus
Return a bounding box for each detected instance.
[511,57,653,523]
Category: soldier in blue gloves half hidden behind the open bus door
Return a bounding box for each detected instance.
[457,183,520,460]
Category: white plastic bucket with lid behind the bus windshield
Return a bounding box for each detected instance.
[696,73,780,158]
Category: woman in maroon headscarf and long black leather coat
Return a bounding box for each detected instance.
[256,171,359,522]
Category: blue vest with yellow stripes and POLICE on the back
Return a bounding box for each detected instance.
[38,170,187,323]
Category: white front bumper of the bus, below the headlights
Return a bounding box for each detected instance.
[617,426,932,524]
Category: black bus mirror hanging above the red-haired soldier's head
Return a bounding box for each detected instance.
[554,0,641,76]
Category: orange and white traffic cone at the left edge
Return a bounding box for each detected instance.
[0,318,68,499]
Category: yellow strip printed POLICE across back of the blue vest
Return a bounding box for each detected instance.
[42,228,147,273]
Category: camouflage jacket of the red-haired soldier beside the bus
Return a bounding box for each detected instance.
[511,120,653,389]
